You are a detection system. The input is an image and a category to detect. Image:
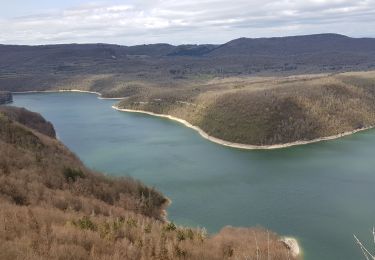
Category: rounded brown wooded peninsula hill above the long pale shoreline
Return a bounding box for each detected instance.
[119,72,375,145]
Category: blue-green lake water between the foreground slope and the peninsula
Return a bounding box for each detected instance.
[14,93,375,260]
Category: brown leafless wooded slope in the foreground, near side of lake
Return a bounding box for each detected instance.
[0,108,300,260]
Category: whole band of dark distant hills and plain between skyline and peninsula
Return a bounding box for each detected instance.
[0,34,375,95]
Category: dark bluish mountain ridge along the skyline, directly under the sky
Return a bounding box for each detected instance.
[0,33,375,58]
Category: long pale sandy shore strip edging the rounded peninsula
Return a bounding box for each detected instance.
[112,105,374,150]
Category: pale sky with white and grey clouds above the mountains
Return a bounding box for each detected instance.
[0,0,375,45]
